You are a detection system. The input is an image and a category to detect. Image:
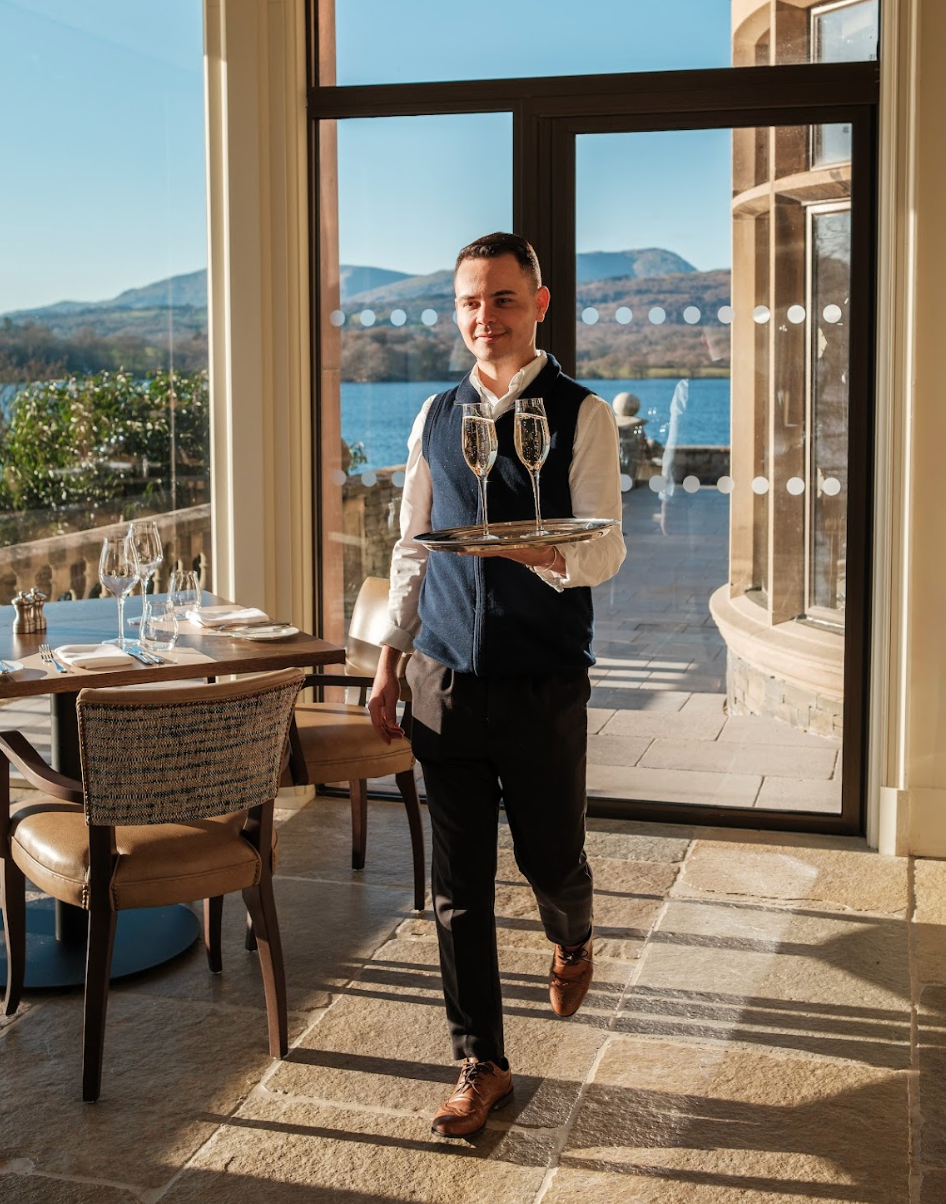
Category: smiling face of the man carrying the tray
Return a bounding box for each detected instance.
[454,255,549,372]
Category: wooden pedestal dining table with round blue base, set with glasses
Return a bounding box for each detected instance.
[0,592,345,988]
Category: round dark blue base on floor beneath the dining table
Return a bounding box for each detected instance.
[0,898,201,990]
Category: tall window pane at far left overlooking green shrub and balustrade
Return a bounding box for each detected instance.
[0,0,211,603]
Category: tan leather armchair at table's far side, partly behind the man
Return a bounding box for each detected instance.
[284,577,426,911]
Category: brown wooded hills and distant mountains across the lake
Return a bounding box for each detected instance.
[0,247,729,382]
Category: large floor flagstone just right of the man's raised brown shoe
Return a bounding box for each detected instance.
[617,902,910,1069]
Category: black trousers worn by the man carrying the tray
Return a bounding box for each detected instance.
[408,653,592,1060]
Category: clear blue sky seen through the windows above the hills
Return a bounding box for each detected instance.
[0,0,729,313]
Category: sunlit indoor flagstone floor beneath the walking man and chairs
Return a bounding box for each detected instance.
[0,798,946,1204]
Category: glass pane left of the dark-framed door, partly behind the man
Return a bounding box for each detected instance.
[319,113,513,638]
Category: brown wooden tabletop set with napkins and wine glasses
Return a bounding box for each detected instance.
[0,594,345,701]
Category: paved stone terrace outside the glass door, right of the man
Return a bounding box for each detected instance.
[589,488,841,813]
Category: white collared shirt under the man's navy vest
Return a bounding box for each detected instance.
[382,352,627,653]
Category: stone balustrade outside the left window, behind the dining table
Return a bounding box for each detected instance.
[0,504,212,604]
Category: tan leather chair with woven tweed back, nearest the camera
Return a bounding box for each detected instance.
[0,669,305,1100]
